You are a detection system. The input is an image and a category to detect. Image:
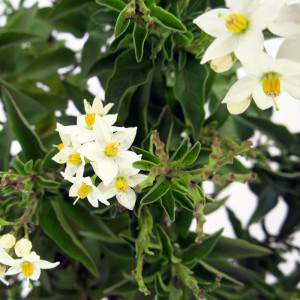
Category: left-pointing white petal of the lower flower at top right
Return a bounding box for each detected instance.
[222,76,258,103]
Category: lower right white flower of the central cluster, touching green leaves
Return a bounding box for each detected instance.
[98,170,147,210]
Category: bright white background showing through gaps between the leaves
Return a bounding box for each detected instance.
[0,0,300,283]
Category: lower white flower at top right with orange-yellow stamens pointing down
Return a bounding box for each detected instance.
[223,53,300,114]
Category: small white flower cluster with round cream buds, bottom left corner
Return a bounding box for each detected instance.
[0,233,59,285]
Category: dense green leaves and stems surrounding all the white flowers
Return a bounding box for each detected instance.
[0,0,300,300]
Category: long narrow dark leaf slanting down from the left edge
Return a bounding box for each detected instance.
[2,87,45,160]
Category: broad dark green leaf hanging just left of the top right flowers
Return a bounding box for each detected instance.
[174,58,209,139]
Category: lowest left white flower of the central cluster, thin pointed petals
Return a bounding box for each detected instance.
[62,168,109,207]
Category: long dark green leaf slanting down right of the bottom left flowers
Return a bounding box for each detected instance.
[39,198,98,276]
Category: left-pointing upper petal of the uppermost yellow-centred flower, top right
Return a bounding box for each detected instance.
[193,8,229,37]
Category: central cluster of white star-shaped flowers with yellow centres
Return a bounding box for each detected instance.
[53,97,146,210]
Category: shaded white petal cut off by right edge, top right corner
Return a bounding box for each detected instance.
[269,3,300,37]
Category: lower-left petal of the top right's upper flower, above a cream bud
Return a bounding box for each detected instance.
[201,35,238,64]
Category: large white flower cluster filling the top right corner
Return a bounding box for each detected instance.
[194,0,300,114]
